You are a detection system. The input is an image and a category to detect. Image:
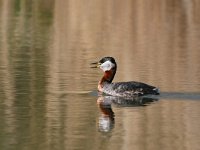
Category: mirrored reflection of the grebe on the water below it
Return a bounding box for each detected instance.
[97,96,158,132]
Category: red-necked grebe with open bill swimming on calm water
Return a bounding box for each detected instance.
[92,57,159,97]
